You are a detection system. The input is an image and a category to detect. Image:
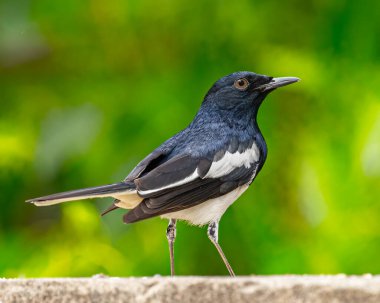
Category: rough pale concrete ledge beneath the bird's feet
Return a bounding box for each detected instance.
[0,275,380,303]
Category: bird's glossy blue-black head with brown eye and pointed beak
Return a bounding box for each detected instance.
[204,72,299,112]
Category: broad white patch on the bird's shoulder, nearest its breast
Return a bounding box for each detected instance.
[204,143,260,178]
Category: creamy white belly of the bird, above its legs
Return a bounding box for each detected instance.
[161,185,248,226]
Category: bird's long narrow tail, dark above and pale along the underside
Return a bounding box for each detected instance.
[26,182,136,206]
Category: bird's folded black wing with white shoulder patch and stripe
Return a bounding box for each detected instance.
[124,141,258,223]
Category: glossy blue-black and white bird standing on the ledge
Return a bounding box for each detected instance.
[26,71,300,276]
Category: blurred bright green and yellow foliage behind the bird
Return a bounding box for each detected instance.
[0,0,380,277]
